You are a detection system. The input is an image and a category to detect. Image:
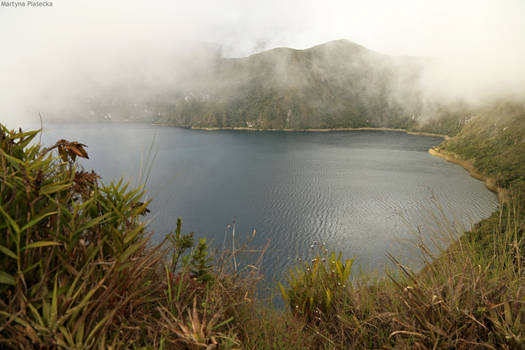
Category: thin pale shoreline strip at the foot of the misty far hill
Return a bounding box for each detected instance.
[152,123,450,140]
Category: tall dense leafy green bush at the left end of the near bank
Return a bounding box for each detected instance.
[0,126,162,348]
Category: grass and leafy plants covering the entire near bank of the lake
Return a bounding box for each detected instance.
[0,127,525,349]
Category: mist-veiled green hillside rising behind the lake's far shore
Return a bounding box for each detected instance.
[51,40,506,136]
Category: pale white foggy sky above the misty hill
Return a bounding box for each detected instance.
[0,0,525,122]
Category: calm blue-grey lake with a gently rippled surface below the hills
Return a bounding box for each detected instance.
[42,123,498,285]
